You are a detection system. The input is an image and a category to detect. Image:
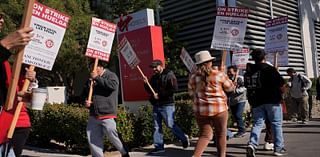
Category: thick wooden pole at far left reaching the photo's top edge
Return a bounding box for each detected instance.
[4,0,35,110]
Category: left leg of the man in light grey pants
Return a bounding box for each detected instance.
[87,116,104,157]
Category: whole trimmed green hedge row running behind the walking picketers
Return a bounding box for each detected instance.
[28,100,198,153]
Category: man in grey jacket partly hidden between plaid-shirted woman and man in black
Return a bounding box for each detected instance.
[227,66,247,138]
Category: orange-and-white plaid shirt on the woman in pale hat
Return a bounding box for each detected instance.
[188,70,234,116]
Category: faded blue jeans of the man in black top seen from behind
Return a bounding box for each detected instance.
[248,104,284,151]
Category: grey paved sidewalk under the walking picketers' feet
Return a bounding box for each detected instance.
[23,118,320,157]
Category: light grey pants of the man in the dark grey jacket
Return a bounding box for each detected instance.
[87,116,127,157]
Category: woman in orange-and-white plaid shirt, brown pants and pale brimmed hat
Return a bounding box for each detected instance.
[188,51,234,157]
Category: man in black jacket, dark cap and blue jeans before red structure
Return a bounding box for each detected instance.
[143,59,190,154]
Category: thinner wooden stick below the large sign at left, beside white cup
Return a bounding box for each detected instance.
[7,65,34,139]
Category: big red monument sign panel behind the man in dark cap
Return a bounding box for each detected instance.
[118,26,164,101]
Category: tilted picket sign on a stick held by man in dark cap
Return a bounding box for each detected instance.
[118,37,156,95]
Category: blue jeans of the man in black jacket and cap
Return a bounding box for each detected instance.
[153,104,188,149]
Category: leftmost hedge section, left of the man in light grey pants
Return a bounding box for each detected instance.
[29,104,88,149]
